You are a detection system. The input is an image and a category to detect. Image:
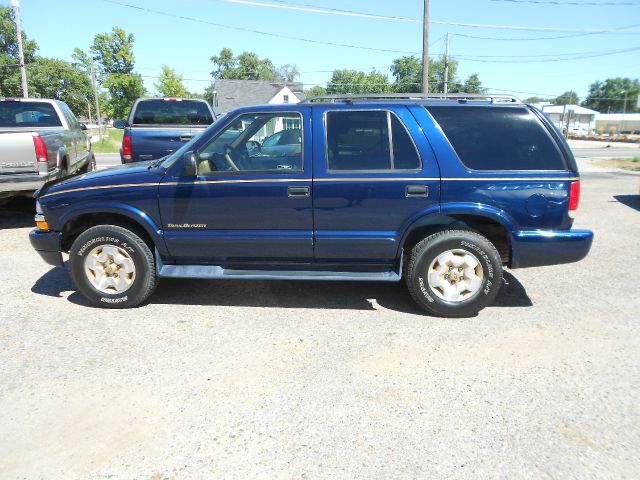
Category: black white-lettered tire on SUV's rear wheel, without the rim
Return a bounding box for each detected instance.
[405,230,502,317]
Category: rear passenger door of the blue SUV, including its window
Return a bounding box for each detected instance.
[313,105,440,264]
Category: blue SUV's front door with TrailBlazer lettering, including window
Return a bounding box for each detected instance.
[159,106,313,265]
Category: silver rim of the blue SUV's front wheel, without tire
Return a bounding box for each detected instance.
[84,245,136,295]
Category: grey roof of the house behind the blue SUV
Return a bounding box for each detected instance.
[214,79,304,113]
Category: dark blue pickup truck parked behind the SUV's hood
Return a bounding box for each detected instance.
[113,97,214,163]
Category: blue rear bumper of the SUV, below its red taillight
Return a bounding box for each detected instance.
[511,230,593,268]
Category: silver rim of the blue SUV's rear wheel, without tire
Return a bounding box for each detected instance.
[428,249,484,303]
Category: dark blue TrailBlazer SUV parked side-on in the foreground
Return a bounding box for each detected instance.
[30,94,593,317]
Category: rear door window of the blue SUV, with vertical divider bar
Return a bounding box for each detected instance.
[327,110,420,171]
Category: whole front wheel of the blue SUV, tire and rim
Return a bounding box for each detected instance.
[69,225,157,308]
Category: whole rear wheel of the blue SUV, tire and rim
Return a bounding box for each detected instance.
[405,230,502,317]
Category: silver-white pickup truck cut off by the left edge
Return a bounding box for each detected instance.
[0,98,95,204]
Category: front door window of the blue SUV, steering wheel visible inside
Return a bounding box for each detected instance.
[198,112,303,175]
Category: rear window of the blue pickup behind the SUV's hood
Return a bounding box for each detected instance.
[133,99,213,125]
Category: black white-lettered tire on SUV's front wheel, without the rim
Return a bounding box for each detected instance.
[69,225,157,308]
